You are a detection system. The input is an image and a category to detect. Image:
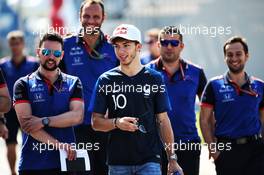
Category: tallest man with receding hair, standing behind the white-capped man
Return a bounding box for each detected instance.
[61,0,118,175]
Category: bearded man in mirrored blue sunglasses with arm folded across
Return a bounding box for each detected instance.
[14,33,84,175]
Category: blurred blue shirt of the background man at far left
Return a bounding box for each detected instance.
[0,56,39,98]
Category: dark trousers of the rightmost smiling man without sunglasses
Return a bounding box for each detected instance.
[215,139,264,175]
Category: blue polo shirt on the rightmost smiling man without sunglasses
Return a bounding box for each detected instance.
[201,73,264,139]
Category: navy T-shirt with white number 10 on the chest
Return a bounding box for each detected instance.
[90,67,170,165]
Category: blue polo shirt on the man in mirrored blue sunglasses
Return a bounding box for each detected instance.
[14,71,82,171]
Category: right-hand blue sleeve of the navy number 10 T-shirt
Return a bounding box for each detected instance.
[154,75,171,114]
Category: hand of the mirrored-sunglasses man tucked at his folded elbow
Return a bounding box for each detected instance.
[21,115,44,133]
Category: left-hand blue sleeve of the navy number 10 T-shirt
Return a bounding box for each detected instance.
[88,77,107,114]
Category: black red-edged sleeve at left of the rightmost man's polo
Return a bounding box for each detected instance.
[201,82,215,108]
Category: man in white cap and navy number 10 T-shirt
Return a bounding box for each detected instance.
[90,24,182,175]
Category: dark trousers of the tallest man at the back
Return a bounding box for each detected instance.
[74,125,108,175]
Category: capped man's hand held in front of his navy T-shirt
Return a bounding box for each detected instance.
[116,117,138,132]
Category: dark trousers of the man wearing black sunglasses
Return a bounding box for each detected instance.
[162,142,201,175]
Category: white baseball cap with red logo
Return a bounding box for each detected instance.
[110,24,141,43]
